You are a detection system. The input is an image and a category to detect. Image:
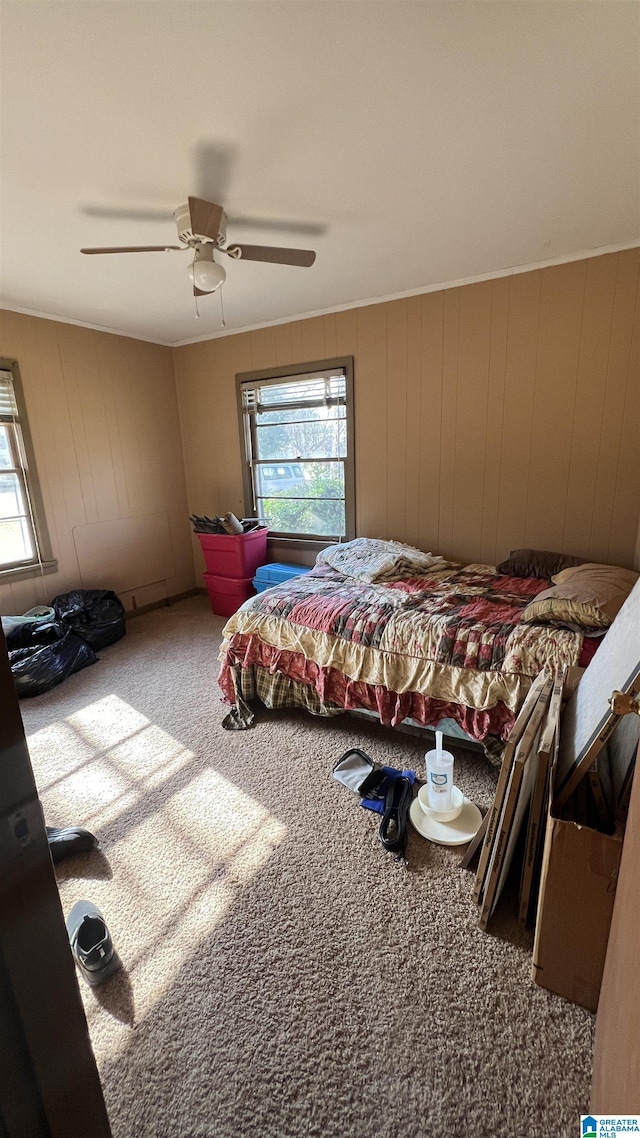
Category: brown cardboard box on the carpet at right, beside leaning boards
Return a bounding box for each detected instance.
[532,811,622,1012]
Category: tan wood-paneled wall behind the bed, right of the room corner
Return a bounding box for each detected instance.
[174,249,640,566]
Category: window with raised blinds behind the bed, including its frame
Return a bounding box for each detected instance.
[237,358,355,542]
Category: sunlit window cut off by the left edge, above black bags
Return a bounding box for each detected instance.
[0,364,56,577]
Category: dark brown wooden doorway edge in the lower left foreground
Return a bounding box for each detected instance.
[0,632,110,1138]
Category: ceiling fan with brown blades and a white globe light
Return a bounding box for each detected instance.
[80,198,315,296]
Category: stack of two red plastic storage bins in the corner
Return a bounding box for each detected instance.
[196,526,269,617]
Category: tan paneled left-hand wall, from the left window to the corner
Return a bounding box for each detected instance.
[0,312,194,613]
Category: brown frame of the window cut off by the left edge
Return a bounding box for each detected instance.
[0,358,58,584]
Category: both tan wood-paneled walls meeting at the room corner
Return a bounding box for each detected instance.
[0,249,640,612]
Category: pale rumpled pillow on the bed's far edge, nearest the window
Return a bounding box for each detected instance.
[315,537,446,585]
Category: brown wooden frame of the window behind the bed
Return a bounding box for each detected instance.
[236,356,355,547]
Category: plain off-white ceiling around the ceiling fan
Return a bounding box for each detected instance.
[0,0,640,344]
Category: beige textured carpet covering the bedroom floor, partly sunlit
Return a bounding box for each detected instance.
[22,597,593,1138]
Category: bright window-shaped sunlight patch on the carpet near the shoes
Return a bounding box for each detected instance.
[28,695,287,1062]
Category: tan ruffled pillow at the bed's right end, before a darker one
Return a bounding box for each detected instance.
[520,561,638,633]
